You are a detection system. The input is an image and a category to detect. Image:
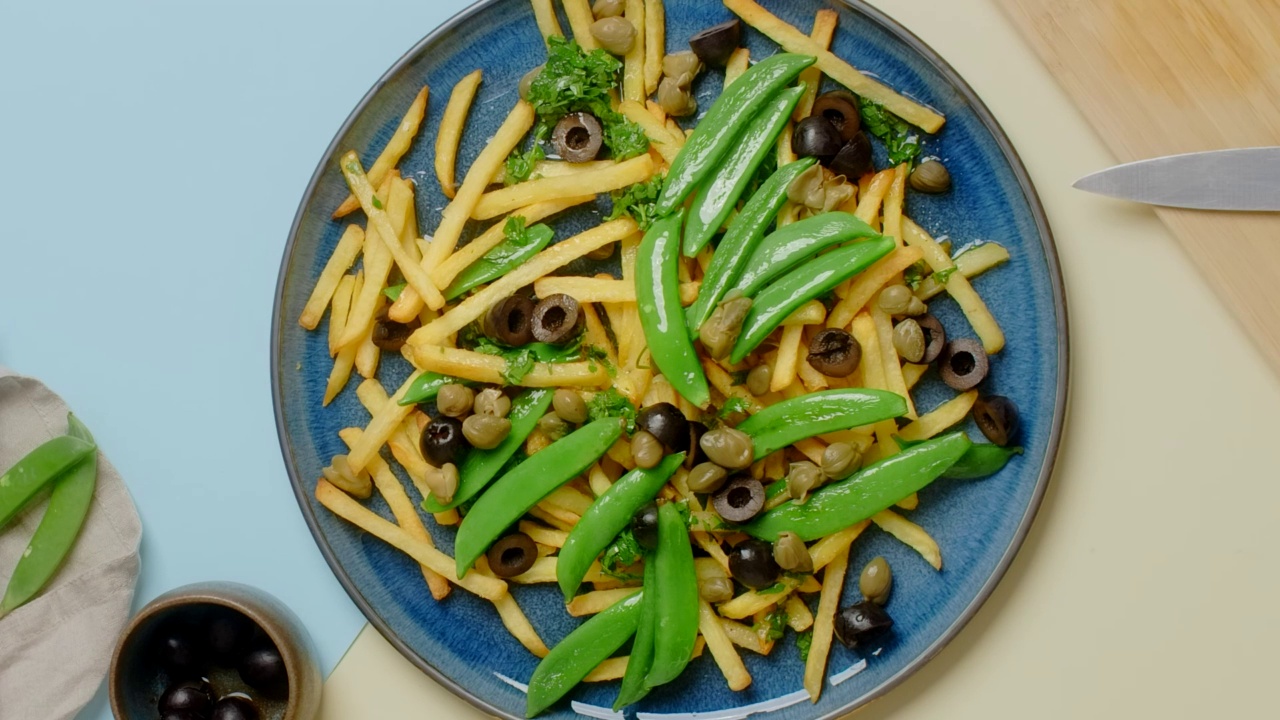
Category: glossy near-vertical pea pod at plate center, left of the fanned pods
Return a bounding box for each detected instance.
[636,213,710,407]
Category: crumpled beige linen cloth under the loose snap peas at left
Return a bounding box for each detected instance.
[0,366,142,720]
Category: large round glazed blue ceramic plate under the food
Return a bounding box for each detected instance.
[271,0,1068,720]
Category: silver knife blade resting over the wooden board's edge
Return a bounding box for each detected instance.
[1074,147,1280,211]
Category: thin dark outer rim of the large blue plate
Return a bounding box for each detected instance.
[270,0,1071,720]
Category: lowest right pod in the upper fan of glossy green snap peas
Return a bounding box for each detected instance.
[730,237,893,363]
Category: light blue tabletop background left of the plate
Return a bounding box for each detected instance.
[0,0,467,719]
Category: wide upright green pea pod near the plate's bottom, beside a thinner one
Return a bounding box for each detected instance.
[644,502,698,688]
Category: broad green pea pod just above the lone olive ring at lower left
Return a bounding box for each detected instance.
[453,418,622,578]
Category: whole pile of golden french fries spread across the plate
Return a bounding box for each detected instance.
[298,0,1009,701]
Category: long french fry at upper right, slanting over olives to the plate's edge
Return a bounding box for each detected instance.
[724,0,946,132]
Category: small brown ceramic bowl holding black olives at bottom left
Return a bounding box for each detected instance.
[108,582,323,720]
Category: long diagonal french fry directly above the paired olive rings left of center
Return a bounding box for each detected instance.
[412,215,636,346]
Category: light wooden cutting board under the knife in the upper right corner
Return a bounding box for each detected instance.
[997,0,1280,373]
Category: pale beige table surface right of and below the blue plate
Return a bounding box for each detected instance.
[321,0,1280,720]
